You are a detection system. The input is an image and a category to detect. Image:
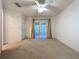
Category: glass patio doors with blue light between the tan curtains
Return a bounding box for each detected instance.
[34,20,48,40]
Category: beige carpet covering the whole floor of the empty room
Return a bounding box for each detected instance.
[0,40,79,59]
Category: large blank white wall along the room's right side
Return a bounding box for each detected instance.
[56,0,79,52]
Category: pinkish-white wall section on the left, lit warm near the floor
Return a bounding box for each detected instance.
[5,10,22,43]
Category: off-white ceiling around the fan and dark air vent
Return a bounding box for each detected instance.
[3,0,72,16]
